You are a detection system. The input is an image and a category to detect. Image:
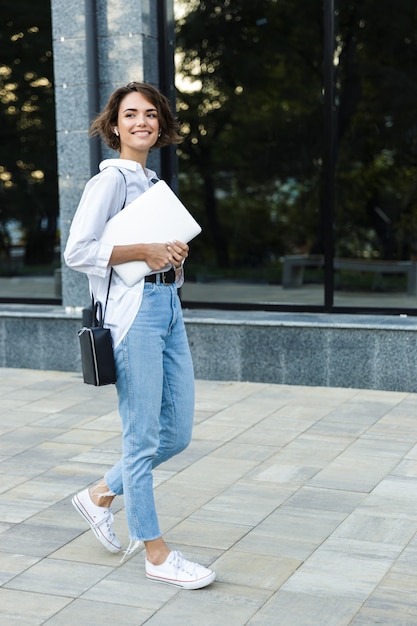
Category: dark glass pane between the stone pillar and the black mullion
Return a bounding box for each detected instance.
[176,0,323,305]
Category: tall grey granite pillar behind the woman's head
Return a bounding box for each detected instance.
[51,0,159,306]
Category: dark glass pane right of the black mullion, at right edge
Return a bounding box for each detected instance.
[334,0,417,308]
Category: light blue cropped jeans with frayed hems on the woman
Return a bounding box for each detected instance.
[105,283,194,541]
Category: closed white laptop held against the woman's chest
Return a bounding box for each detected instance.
[100,180,201,287]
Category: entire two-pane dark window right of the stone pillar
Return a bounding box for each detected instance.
[175,0,417,311]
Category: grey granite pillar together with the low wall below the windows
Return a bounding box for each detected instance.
[6,0,417,392]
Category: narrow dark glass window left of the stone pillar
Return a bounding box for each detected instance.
[0,0,60,302]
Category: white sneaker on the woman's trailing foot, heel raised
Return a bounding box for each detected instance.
[72,489,122,552]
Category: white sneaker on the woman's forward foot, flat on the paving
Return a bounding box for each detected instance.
[145,551,216,589]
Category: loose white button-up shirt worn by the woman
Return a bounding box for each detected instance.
[64,159,184,347]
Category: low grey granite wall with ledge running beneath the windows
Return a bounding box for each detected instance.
[0,305,417,392]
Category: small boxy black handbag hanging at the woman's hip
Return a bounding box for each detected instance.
[78,272,117,387]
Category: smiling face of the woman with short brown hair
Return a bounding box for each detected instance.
[116,91,159,165]
